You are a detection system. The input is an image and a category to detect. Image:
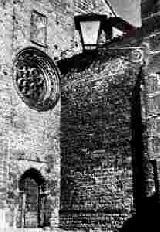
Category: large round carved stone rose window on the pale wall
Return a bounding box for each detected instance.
[13,47,60,111]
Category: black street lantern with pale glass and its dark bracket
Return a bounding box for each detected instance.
[74,13,135,51]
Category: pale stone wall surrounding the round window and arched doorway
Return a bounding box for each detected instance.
[0,1,70,228]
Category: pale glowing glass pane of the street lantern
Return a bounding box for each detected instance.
[80,20,100,46]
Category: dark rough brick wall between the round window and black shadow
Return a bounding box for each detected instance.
[59,48,143,231]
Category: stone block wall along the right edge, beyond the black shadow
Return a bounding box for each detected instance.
[143,13,160,196]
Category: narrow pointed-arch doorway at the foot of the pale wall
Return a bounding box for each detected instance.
[19,168,47,228]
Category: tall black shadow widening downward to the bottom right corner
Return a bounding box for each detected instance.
[119,66,160,232]
